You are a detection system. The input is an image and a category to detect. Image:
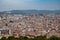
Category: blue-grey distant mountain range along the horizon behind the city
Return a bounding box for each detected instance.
[0,10,60,15]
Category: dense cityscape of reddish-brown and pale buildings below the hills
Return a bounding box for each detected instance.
[0,12,60,38]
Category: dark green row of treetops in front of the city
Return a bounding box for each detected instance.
[0,36,60,40]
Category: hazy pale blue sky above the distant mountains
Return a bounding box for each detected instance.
[0,0,60,11]
